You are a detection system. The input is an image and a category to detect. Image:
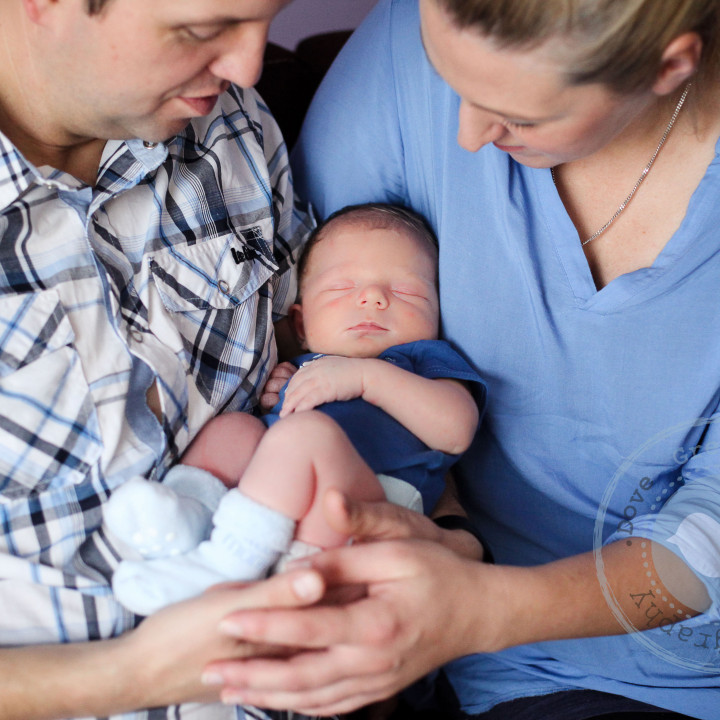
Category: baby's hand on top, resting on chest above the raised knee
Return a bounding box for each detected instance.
[280,355,368,417]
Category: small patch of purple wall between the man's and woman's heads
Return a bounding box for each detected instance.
[270,0,376,50]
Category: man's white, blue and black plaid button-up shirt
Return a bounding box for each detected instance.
[0,89,310,718]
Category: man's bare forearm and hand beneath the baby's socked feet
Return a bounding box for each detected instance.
[0,570,324,720]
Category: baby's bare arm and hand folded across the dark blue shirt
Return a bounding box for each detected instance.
[281,356,478,455]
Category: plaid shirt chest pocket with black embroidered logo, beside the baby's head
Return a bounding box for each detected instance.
[150,231,277,407]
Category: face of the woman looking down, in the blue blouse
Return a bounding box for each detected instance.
[420,0,657,168]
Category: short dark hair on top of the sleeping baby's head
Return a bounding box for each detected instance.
[298,203,438,296]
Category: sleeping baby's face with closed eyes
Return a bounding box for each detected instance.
[292,224,440,357]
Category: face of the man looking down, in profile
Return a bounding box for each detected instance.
[39,0,290,141]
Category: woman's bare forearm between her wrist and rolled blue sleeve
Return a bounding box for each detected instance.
[477,538,709,650]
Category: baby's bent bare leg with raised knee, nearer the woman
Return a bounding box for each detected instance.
[239,411,385,547]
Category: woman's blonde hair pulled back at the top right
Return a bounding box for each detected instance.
[436,0,720,93]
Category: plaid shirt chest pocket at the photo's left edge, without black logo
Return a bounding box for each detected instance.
[0,290,102,502]
